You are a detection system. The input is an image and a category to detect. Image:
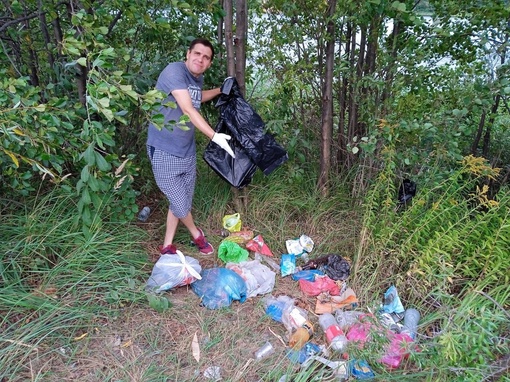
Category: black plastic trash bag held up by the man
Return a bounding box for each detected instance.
[204,77,288,188]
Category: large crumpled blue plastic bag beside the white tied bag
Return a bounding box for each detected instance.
[191,268,247,309]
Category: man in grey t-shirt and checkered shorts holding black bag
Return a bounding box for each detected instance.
[147,38,234,254]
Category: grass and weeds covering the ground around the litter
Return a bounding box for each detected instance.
[0,150,510,382]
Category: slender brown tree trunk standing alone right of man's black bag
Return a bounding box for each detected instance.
[318,0,336,196]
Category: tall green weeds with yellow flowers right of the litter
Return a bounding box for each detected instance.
[353,143,510,381]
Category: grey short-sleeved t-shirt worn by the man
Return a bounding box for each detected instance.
[147,62,204,158]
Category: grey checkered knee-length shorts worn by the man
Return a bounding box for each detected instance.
[147,146,197,219]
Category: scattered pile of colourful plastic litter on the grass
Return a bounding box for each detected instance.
[147,214,420,382]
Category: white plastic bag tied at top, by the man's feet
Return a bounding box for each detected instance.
[147,250,202,293]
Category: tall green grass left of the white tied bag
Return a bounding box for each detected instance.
[0,190,148,380]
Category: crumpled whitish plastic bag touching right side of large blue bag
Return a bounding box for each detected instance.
[225,260,276,298]
